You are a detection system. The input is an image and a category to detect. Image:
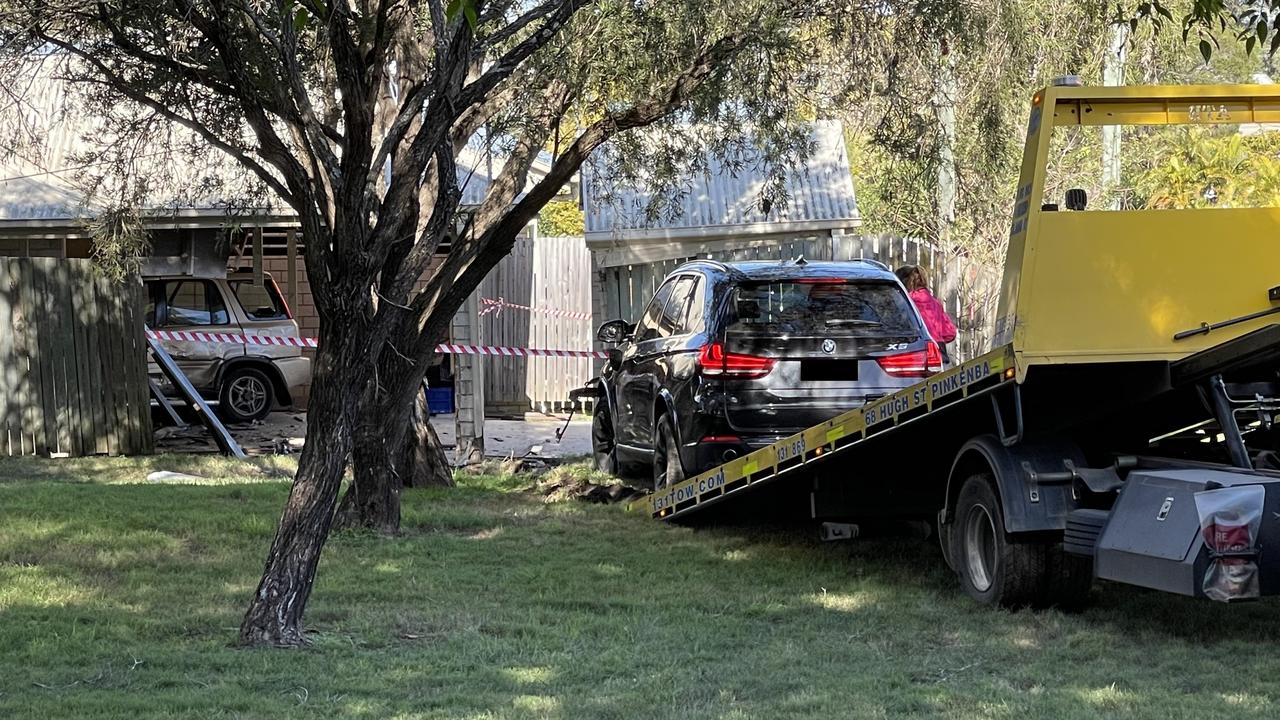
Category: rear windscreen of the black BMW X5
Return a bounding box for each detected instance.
[731,278,919,337]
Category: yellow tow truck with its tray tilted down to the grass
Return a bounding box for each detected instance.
[634,86,1280,606]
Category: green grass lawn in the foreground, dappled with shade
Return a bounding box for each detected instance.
[0,457,1280,720]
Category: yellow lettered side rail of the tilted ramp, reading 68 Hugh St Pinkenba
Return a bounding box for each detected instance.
[631,346,1014,519]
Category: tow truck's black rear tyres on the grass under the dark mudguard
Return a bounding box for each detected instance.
[951,473,1093,609]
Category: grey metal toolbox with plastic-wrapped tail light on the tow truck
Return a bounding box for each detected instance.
[1064,461,1280,602]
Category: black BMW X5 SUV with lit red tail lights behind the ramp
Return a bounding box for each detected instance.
[575,259,942,487]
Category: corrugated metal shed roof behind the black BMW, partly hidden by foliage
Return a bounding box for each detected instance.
[582,122,859,240]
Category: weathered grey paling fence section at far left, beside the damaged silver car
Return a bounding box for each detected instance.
[0,258,152,456]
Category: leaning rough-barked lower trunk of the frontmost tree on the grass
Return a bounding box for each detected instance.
[239,335,365,647]
